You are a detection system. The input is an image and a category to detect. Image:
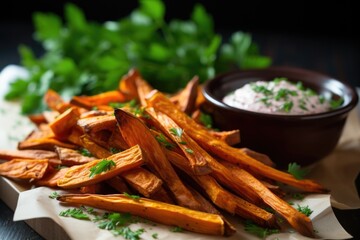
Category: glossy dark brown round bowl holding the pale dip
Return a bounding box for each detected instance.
[203,67,358,169]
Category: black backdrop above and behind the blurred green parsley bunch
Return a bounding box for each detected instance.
[0,0,360,86]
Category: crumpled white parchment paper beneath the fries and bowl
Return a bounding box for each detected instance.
[0,66,360,240]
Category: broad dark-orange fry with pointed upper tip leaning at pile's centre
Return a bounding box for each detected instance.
[115,109,201,210]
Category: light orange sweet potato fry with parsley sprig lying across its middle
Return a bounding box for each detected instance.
[57,145,144,189]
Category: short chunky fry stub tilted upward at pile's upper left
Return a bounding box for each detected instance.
[49,107,80,140]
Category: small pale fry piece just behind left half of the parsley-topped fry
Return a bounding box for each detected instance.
[55,146,96,166]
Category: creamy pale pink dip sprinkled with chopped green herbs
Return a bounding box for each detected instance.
[223,78,331,115]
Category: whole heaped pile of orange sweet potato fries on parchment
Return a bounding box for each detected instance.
[0,69,327,237]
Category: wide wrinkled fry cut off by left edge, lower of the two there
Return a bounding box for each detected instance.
[0,159,49,179]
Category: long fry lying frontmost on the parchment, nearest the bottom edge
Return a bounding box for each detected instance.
[57,194,229,236]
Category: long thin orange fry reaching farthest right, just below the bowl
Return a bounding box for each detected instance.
[147,91,328,193]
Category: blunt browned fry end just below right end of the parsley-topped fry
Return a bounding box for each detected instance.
[121,168,162,197]
